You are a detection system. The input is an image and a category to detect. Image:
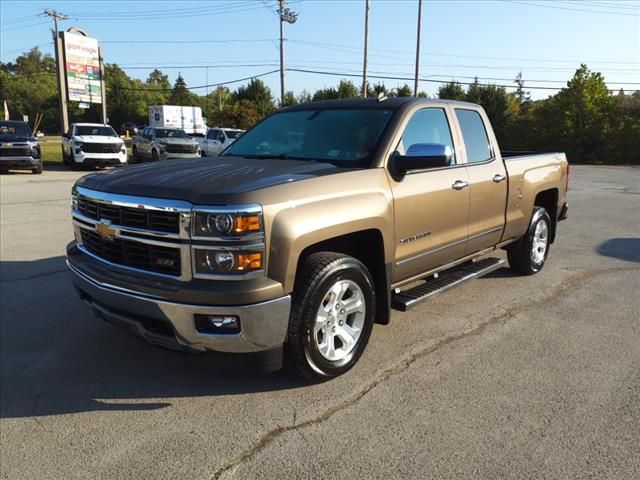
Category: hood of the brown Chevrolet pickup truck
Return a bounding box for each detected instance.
[76,157,347,205]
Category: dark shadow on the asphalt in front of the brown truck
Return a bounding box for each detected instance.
[0,256,305,418]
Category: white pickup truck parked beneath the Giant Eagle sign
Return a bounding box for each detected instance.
[62,123,127,168]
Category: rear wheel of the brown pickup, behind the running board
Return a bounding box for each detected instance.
[507,207,551,275]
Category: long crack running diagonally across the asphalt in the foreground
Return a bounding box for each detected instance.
[211,267,640,480]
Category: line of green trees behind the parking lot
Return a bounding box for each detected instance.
[0,48,640,164]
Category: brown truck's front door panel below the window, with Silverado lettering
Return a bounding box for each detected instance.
[391,167,469,282]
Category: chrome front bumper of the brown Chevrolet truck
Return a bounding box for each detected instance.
[67,260,291,353]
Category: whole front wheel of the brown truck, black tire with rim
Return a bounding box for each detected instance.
[285,252,375,382]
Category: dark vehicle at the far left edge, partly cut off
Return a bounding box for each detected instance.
[0,120,42,174]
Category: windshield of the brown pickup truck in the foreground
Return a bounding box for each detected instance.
[223,108,392,167]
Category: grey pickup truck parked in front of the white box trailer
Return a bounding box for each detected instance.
[131,127,200,162]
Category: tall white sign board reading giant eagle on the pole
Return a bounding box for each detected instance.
[64,32,102,103]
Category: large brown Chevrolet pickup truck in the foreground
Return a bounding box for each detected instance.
[67,97,569,381]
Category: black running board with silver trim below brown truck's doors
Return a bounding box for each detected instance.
[391,258,505,312]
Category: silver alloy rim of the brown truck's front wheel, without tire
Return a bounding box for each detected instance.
[313,280,367,362]
